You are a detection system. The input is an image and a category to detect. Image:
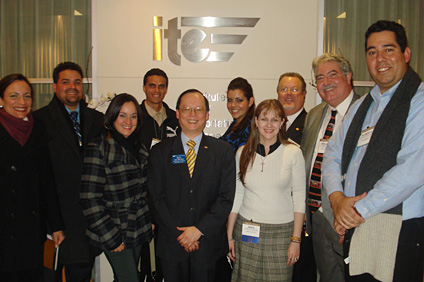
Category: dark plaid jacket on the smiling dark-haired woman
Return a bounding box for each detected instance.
[80,135,152,250]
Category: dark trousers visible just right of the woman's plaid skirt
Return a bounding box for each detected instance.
[292,226,317,282]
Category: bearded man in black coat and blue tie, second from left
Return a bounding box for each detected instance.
[34,62,103,282]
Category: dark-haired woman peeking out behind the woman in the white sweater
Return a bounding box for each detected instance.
[220,77,255,154]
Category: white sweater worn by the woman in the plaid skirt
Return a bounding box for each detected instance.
[231,144,306,224]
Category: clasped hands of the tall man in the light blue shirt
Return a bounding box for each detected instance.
[330,191,367,243]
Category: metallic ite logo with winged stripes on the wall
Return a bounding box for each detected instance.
[153,16,260,66]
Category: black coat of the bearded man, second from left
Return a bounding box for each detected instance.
[34,97,104,264]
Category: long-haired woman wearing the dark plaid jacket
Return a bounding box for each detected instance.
[80,93,152,282]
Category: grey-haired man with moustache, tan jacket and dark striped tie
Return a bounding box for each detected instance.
[301,53,359,282]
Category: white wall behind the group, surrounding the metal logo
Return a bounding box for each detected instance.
[93,0,319,281]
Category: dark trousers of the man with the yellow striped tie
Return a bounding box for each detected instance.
[161,256,216,282]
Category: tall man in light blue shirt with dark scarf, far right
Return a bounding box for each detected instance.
[323,21,424,282]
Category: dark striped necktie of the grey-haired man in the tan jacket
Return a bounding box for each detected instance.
[308,110,337,213]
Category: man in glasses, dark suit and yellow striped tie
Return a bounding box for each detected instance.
[148,89,236,282]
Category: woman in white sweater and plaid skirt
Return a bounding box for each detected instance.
[227,100,306,282]
